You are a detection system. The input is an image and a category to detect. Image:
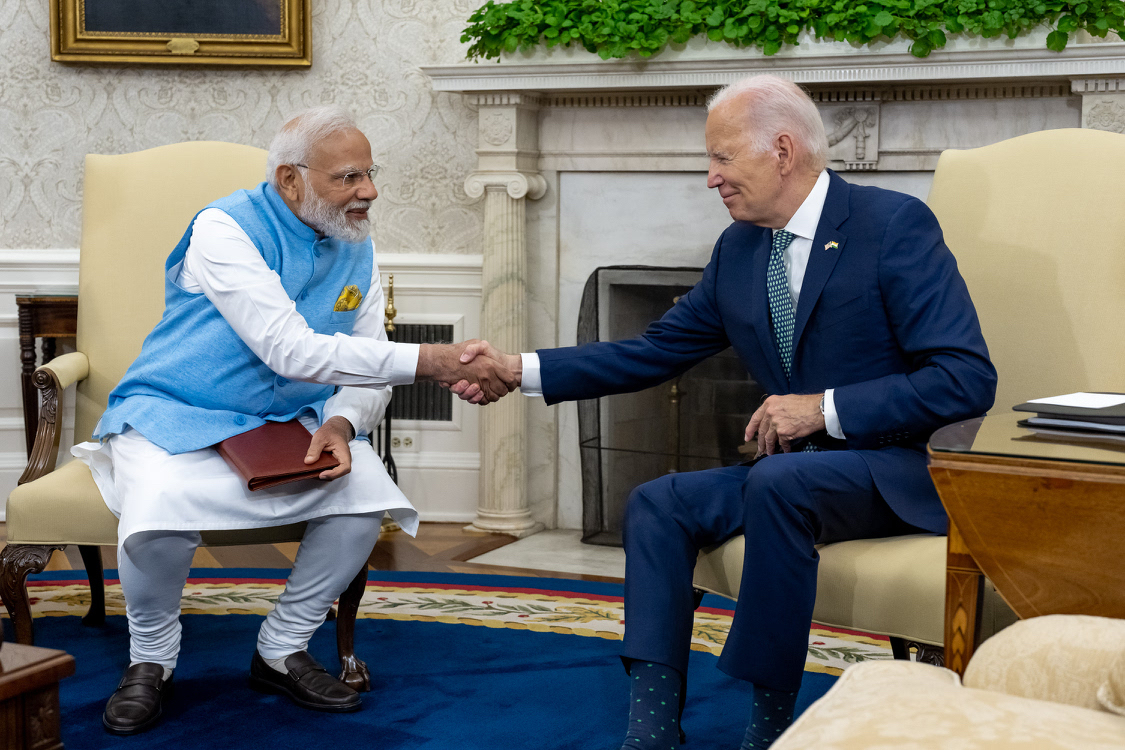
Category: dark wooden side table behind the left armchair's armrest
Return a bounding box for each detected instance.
[16,295,78,455]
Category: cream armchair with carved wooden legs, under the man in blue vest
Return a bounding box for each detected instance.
[0,142,378,690]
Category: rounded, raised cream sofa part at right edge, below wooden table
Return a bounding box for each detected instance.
[964,615,1125,710]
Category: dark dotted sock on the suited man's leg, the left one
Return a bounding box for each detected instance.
[621,659,683,750]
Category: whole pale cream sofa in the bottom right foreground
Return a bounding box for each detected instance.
[773,615,1125,750]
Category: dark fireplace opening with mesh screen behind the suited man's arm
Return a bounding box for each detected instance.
[578,265,763,546]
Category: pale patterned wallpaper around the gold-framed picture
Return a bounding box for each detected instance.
[0,0,484,253]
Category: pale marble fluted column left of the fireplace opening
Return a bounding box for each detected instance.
[465,94,547,536]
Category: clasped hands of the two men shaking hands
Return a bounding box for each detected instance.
[415,340,523,404]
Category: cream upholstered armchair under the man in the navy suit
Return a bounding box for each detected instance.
[695,129,1125,663]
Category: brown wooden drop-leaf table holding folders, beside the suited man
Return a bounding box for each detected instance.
[929,414,1125,675]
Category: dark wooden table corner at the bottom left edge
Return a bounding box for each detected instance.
[0,643,74,750]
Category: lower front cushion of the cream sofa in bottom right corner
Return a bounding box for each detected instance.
[773,661,1125,750]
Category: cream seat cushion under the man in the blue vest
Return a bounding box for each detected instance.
[7,460,305,546]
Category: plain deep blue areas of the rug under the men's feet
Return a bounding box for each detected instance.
[36,570,836,750]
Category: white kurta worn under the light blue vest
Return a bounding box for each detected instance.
[71,209,419,543]
